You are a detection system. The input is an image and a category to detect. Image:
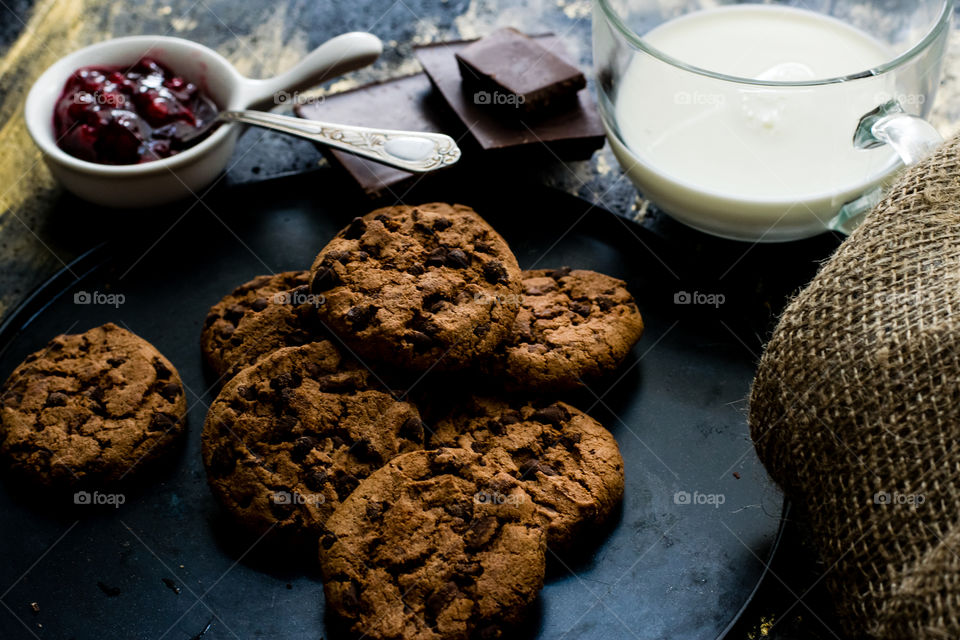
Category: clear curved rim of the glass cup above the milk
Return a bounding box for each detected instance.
[596,0,954,87]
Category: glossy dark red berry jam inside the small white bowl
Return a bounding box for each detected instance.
[53,58,217,164]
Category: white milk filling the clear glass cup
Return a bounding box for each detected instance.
[612,5,899,240]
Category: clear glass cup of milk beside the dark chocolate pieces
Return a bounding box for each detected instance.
[593,0,953,242]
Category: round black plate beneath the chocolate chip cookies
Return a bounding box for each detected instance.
[0,176,782,640]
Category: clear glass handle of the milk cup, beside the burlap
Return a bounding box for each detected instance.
[828,100,943,234]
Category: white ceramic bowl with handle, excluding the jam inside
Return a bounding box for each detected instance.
[24,32,382,208]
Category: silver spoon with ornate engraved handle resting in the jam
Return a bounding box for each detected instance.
[182,111,460,173]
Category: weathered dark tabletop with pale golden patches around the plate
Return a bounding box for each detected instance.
[0,0,960,640]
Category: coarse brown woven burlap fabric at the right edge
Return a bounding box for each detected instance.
[750,132,960,640]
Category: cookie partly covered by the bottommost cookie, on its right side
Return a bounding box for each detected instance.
[430,397,624,550]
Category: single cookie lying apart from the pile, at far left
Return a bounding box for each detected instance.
[0,324,187,489]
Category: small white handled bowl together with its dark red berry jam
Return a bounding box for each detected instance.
[24,32,382,208]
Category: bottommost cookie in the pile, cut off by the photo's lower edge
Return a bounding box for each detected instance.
[320,449,544,640]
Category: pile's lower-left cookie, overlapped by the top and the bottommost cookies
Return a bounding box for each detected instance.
[202,341,424,544]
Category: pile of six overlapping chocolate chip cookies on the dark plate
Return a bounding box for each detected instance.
[202,203,643,639]
